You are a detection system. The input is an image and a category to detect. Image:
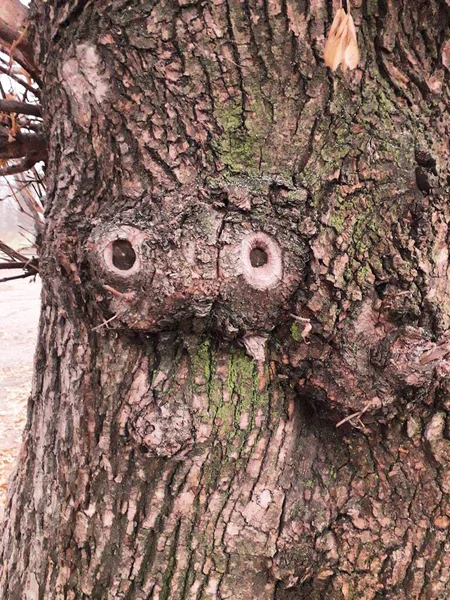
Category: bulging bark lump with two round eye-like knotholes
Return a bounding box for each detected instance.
[86,197,306,339]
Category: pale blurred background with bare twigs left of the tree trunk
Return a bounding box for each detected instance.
[0,0,45,520]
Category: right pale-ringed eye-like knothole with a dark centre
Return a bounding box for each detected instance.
[241,231,283,290]
